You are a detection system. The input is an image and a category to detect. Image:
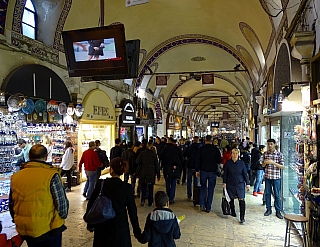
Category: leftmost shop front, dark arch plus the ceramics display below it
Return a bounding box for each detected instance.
[0,65,77,212]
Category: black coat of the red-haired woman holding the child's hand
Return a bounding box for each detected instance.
[87,178,141,247]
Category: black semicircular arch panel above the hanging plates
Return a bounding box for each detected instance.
[1,64,71,103]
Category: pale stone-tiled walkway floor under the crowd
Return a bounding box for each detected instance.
[0,175,302,247]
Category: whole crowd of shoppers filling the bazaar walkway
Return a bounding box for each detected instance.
[4,135,284,247]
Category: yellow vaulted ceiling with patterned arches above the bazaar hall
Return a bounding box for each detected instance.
[64,0,288,126]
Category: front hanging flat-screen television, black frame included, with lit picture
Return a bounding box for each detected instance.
[62,24,129,77]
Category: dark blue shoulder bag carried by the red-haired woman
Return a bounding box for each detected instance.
[83,180,116,224]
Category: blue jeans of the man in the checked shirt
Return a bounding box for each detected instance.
[264,178,282,211]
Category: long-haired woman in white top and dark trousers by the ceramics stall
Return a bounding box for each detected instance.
[60,141,74,192]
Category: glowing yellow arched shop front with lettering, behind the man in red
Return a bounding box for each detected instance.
[78,89,116,179]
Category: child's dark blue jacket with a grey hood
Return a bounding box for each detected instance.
[143,208,181,247]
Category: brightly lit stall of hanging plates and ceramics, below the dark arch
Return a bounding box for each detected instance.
[0,94,83,211]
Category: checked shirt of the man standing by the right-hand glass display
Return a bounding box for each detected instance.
[263,150,284,179]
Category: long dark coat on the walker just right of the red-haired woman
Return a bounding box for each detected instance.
[136,149,160,184]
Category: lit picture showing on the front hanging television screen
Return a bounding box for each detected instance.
[73,38,120,62]
